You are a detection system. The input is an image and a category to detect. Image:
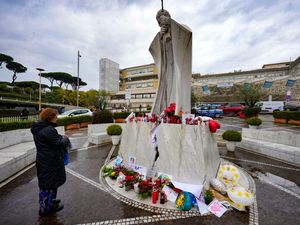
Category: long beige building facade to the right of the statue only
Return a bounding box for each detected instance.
[192,57,300,103]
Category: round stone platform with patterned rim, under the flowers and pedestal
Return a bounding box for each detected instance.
[99,156,255,216]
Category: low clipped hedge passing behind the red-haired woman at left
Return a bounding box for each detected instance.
[0,115,93,132]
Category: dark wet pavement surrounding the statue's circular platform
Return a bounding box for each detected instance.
[0,119,300,225]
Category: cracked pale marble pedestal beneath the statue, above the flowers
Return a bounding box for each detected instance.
[119,122,220,184]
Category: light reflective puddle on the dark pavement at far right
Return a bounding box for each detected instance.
[255,171,300,195]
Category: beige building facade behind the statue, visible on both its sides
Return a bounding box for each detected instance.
[110,57,300,112]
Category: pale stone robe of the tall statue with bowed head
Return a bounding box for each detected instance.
[149,19,192,115]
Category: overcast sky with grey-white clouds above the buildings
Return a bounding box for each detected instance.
[0,0,300,89]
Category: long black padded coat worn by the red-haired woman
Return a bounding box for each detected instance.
[31,121,70,189]
